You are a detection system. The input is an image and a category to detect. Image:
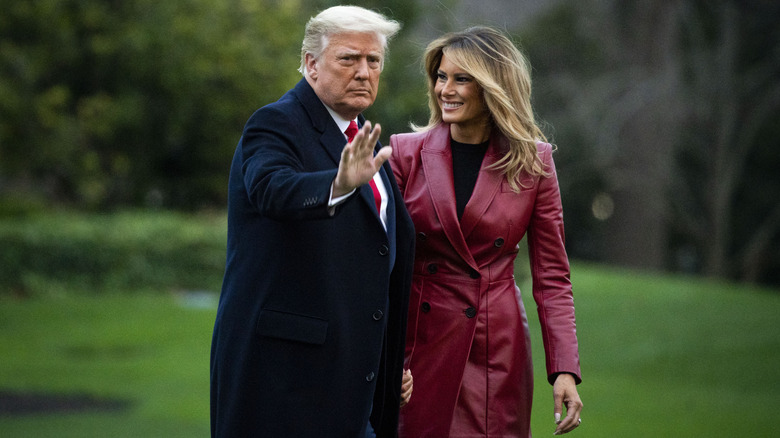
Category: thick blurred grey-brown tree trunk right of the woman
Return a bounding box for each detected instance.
[606,2,679,269]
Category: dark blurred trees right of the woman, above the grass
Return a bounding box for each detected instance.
[524,0,780,281]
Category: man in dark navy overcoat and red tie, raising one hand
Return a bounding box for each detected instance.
[211,6,414,438]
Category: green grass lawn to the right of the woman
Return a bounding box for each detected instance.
[524,263,780,437]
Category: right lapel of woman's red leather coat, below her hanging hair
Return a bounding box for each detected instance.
[460,135,508,241]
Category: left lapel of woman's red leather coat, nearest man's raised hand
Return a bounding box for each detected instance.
[420,123,479,269]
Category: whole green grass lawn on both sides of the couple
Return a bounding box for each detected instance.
[0,263,780,438]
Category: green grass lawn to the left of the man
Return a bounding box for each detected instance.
[0,293,215,437]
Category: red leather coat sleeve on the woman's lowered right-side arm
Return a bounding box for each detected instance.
[528,144,581,383]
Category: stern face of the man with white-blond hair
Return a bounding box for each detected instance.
[306,33,384,120]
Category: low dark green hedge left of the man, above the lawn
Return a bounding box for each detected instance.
[0,212,226,296]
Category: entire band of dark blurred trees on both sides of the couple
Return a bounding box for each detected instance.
[0,0,780,283]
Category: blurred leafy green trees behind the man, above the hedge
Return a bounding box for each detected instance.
[0,0,424,209]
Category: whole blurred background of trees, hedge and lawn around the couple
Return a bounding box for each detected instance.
[0,0,780,436]
